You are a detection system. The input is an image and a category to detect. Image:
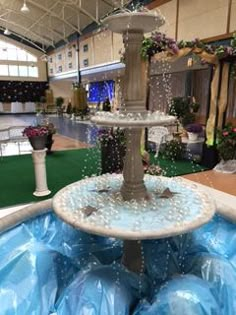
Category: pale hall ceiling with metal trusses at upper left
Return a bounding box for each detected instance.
[0,0,131,50]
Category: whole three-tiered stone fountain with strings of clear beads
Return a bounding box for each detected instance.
[53,12,215,271]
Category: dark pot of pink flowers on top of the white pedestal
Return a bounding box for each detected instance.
[23,126,48,150]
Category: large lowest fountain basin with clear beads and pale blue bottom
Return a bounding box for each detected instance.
[53,174,215,240]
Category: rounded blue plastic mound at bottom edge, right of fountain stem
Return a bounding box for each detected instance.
[134,275,221,315]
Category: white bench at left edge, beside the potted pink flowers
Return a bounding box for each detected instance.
[0,126,28,157]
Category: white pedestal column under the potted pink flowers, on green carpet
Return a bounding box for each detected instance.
[32,149,51,197]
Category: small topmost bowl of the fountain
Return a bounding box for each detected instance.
[103,12,165,33]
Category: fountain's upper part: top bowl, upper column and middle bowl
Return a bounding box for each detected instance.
[91,11,176,128]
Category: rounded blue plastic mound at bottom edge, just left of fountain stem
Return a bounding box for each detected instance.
[56,264,148,315]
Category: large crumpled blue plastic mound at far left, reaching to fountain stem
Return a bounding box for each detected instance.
[0,213,121,315]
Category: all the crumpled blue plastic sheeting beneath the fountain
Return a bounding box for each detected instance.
[0,213,236,315]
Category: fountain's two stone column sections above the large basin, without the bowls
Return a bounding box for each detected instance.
[121,30,147,200]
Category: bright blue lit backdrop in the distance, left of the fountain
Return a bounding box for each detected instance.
[88,80,114,103]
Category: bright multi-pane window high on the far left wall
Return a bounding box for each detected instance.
[0,40,38,78]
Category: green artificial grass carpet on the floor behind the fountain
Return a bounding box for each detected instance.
[0,148,205,208]
